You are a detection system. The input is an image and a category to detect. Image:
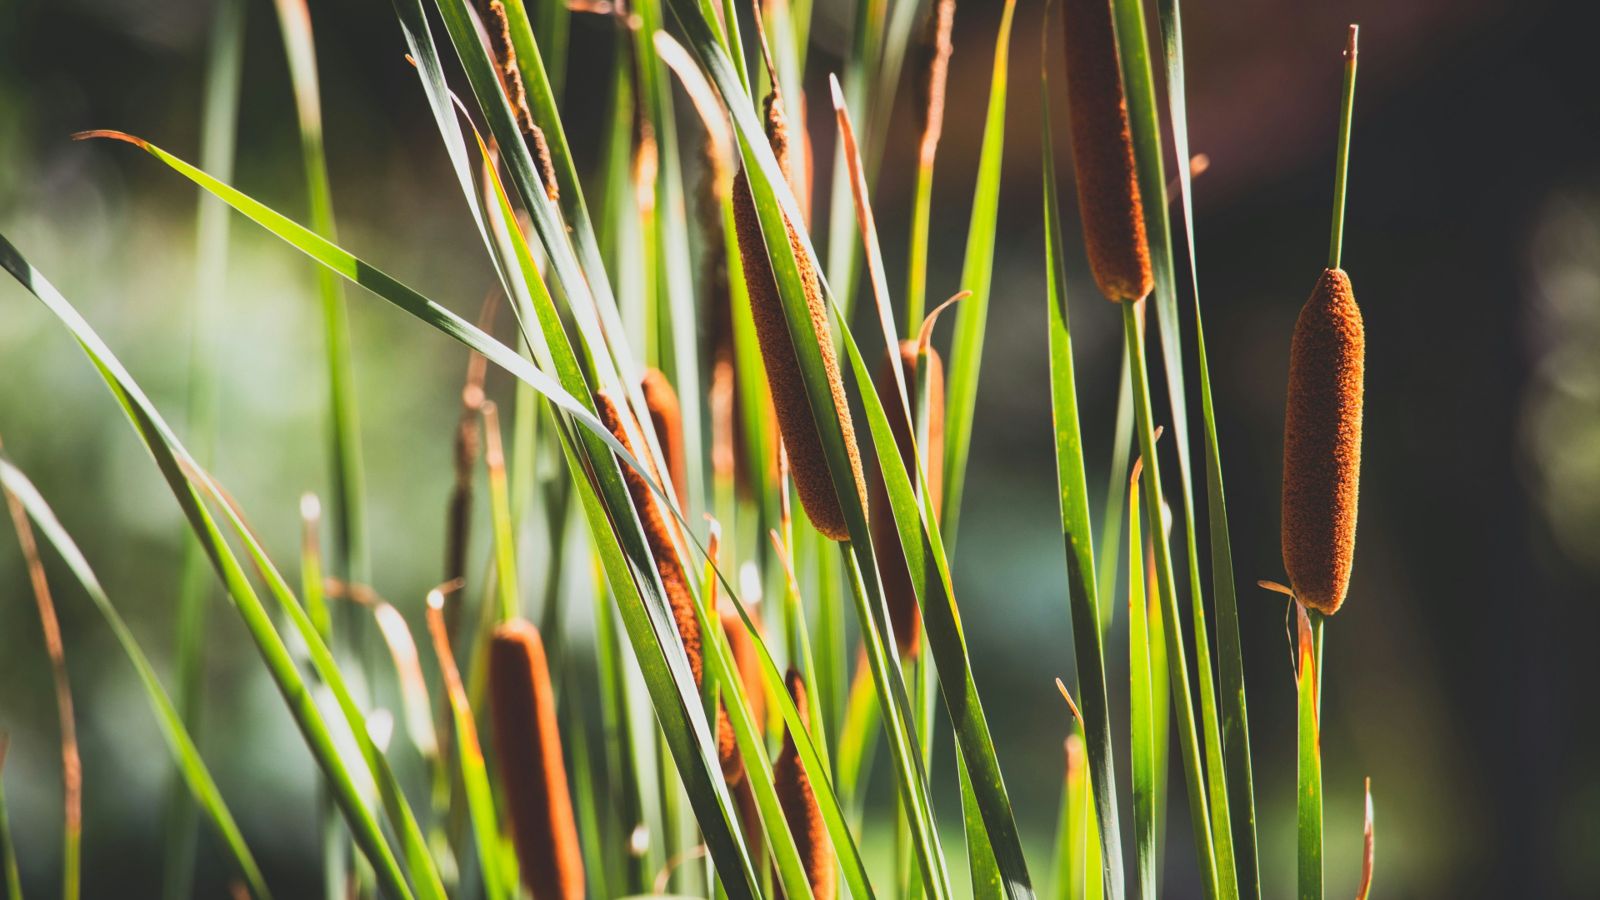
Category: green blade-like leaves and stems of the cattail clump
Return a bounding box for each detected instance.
[0,0,1376,900]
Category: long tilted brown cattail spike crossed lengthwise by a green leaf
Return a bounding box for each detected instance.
[733,91,867,541]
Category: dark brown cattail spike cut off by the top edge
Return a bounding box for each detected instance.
[1061,0,1154,301]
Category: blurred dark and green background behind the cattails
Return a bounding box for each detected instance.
[0,0,1600,897]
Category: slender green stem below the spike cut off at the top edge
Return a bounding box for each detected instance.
[1118,301,1218,898]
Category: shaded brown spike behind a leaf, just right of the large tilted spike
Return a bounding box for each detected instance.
[867,341,944,657]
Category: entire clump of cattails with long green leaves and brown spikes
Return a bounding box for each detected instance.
[0,0,1401,900]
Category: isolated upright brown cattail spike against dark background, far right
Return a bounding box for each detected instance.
[1283,269,1366,615]
